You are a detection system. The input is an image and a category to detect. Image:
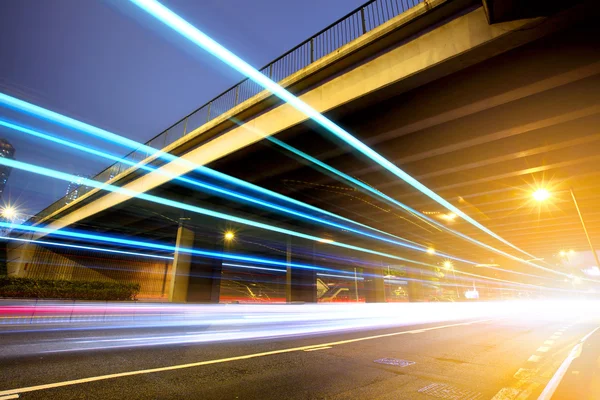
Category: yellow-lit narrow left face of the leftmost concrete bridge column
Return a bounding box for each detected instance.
[169,224,195,303]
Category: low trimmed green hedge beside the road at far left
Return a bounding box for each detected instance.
[0,276,140,300]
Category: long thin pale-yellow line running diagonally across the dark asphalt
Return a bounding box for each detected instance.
[0,319,492,396]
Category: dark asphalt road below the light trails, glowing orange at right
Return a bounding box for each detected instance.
[0,306,600,400]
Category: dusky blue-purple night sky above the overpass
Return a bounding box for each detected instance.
[0,0,364,214]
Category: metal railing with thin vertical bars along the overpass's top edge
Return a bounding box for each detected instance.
[30,0,424,221]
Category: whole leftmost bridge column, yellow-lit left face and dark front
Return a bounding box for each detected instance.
[169,224,222,303]
